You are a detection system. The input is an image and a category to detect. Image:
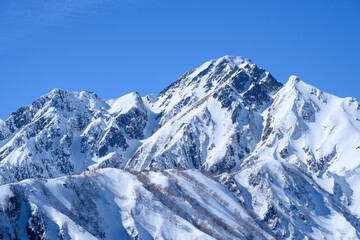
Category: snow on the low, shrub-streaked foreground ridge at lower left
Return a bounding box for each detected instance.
[0,168,271,239]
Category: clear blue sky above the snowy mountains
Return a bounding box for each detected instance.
[0,0,360,119]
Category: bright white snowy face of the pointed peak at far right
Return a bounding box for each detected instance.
[258,76,360,176]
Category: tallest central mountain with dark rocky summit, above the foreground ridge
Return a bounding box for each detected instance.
[127,56,281,172]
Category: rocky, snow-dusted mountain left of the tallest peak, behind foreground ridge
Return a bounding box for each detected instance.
[0,89,148,183]
